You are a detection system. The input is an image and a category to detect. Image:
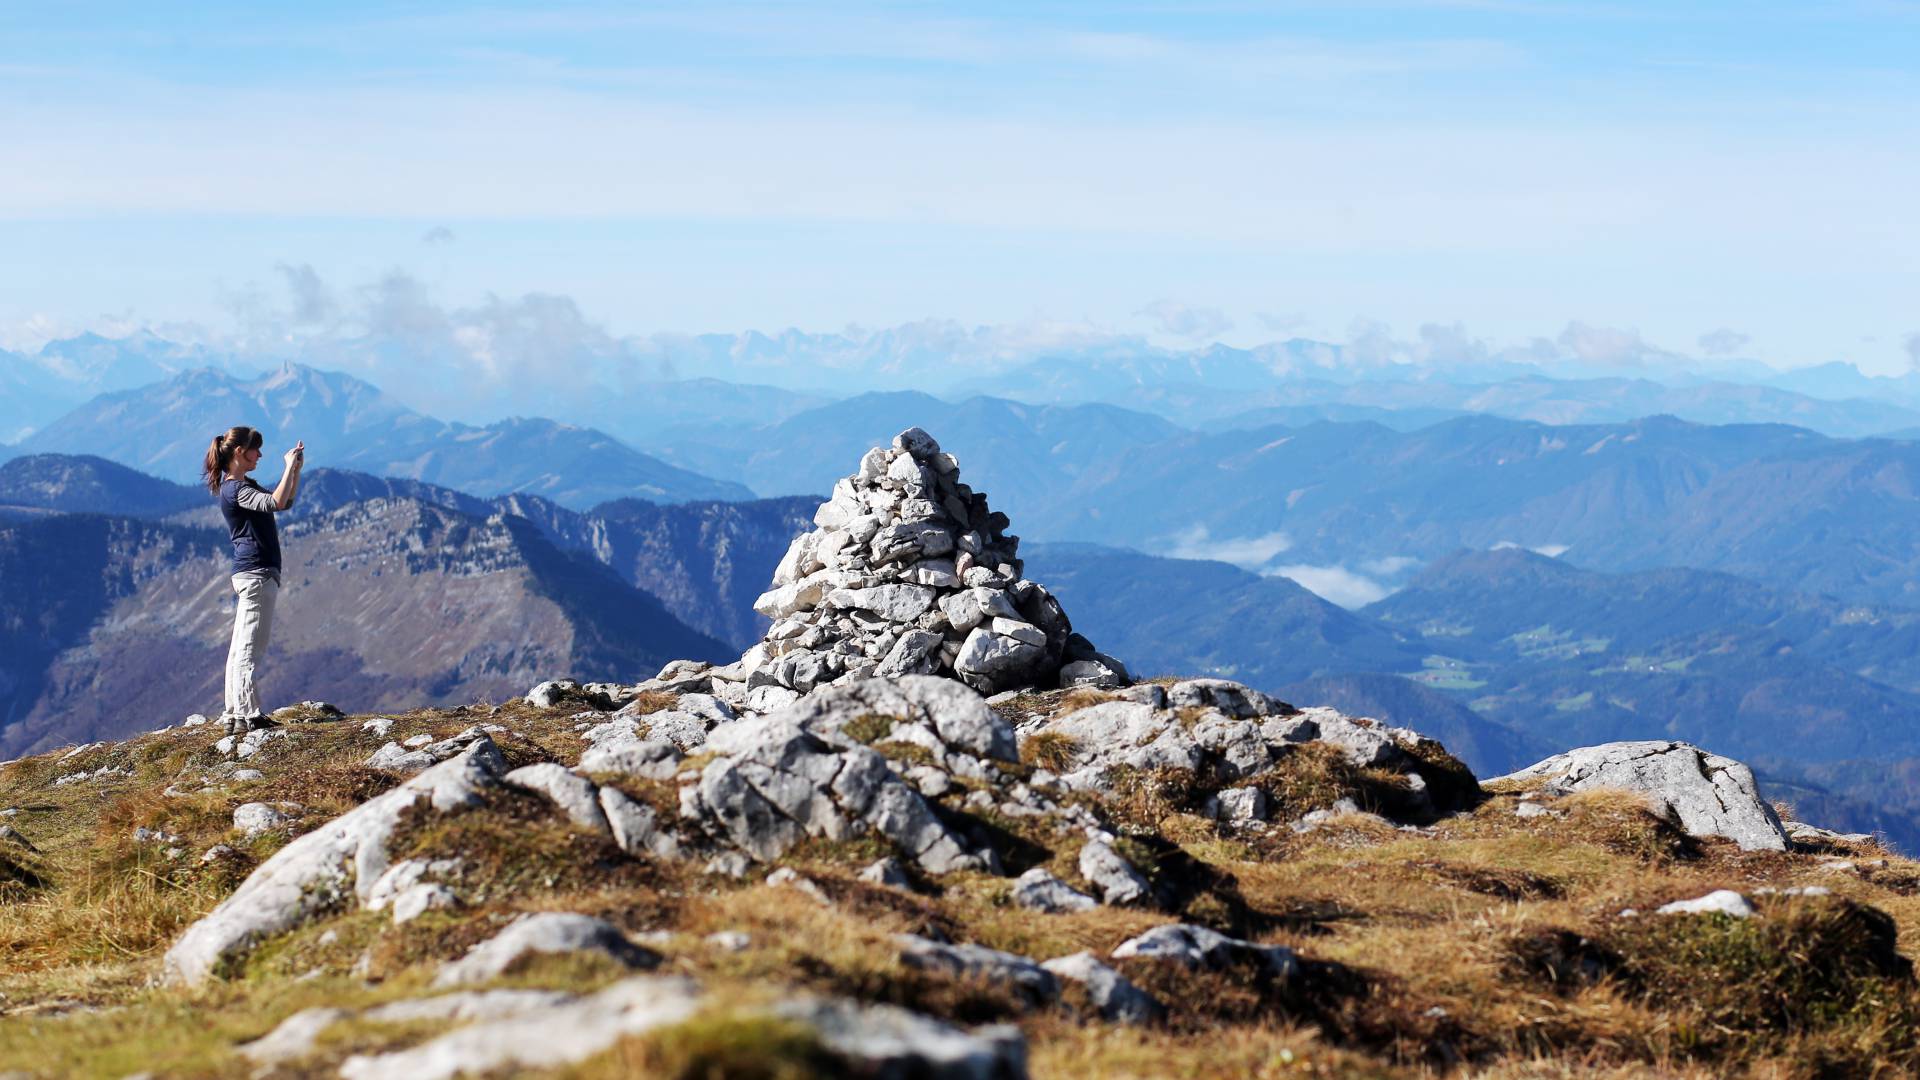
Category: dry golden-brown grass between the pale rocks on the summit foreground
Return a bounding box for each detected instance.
[0,692,1920,1080]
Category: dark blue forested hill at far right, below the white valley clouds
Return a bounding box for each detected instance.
[1363,550,1920,761]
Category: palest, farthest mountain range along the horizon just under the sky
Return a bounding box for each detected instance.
[11,319,1920,452]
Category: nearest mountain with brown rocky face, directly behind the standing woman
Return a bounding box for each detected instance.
[0,500,730,755]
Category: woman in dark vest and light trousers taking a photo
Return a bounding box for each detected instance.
[202,427,307,734]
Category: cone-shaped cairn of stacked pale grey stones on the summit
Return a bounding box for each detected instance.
[729,427,1129,703]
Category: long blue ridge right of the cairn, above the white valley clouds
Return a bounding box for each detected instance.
[1021,409,1920,603]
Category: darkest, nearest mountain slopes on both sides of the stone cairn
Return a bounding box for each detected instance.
[0,449,1920,844]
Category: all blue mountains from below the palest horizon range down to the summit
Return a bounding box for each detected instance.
[11,342,1920,840]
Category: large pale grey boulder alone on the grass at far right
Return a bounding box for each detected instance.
[1490,740,1789,851]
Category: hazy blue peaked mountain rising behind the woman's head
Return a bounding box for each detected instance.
[23,365,751,509]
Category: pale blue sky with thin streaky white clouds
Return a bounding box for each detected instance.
[0,0,1920,371]
